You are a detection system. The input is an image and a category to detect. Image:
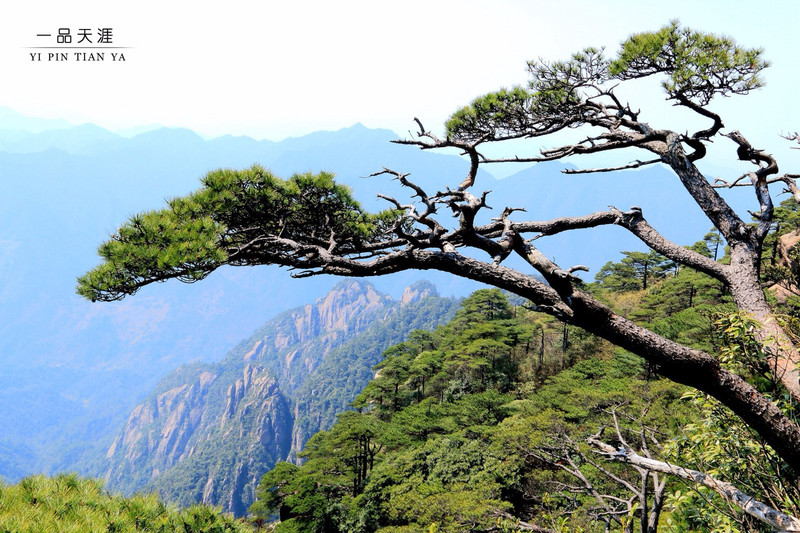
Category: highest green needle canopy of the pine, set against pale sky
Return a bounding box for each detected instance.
[445,21,769,142]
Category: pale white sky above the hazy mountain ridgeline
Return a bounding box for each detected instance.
[0,0,800,166]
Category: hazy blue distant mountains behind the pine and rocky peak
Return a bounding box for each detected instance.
[0,109,753,482]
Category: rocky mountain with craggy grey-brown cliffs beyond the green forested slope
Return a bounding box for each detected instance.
[98,280,457,515]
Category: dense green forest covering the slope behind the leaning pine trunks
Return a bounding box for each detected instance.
[251,196,800,533]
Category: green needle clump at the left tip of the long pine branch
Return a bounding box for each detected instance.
[78,169,396,301]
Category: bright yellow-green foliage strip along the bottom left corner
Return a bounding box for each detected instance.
[0,474,253,533]
